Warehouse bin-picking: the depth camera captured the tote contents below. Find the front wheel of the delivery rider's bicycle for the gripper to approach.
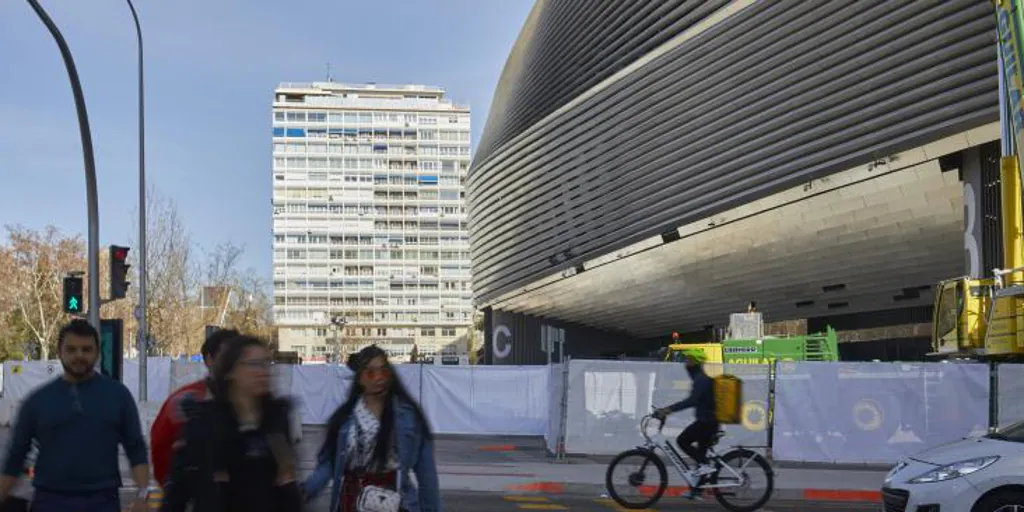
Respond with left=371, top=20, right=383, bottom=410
left=604, top=449, right=669, bottom=509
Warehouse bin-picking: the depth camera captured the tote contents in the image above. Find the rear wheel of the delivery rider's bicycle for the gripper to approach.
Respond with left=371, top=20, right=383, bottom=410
left=712, top=449, right=775, bottom=512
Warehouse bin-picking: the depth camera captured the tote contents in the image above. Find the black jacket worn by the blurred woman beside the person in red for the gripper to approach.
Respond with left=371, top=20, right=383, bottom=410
left=161, top=398, right=301, bottom=512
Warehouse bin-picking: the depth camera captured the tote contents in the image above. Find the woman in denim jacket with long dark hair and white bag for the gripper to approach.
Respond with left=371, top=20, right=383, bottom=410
left=302, top=346, right=441, bottom=512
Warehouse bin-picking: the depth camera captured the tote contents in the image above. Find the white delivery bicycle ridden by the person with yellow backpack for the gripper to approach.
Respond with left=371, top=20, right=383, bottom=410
left=605, top=415, right=775, bottom=512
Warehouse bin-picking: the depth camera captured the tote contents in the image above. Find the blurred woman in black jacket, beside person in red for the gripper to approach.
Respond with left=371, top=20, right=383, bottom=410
left=164, top=336, right=301, bottom=512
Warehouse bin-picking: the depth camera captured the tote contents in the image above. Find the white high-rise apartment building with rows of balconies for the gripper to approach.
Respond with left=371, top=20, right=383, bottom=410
left=272, top=82, right=472, bottom=362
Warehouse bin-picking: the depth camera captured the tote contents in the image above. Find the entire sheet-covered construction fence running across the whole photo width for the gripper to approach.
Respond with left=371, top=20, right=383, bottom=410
left=0, top=357, right=1024, bottom=463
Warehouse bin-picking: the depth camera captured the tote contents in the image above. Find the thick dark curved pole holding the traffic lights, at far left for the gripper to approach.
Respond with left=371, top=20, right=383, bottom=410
left=28, top=0, right=101, bottom=331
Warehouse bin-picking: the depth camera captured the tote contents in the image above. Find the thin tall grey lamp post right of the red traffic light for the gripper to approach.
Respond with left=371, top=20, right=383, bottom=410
left=126, top=0, right=150, bottom=401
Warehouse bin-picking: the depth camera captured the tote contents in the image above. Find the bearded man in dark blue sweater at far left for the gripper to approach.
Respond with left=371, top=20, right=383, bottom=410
left=0, top=319, right=150, bottom=512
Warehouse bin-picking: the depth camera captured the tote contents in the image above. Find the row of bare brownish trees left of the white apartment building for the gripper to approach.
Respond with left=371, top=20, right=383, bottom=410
left=0, top=190, right=276, bottom=357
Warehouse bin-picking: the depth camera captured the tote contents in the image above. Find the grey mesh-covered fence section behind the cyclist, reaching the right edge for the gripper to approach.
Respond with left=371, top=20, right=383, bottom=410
left=548, top=360, right=1024, bottom=463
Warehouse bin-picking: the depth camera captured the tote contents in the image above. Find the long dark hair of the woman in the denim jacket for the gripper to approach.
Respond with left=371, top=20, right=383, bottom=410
left=319, top=345, right=433, bottom=469
